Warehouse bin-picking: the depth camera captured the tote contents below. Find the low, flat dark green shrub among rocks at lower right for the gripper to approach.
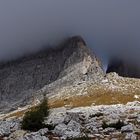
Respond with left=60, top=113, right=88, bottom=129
left=102, top=120, right=125, bottom=130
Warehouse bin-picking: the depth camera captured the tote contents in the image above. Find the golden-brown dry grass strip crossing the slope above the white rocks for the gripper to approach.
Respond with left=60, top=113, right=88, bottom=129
left=3, top=87, right=140, bottom=118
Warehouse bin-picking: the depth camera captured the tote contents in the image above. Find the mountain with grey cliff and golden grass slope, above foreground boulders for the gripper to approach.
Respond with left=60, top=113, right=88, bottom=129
left=0, top=36, right=140, bottom=112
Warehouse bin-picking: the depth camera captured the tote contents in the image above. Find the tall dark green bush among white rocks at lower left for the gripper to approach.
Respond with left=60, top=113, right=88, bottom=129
left=21, top=98, right=49, bottom=131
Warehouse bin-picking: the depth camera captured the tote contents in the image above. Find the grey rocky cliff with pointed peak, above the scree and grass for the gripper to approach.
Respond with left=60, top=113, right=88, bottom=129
left=0, top=36, right=103, bottom=111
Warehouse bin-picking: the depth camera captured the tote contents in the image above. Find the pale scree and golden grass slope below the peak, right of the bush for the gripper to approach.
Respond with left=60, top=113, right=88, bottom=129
left=46, top=73, right=140, bottom=107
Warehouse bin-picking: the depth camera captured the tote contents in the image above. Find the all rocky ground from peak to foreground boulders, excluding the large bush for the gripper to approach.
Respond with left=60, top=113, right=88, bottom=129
left=0, top=36, right=140, bottom=140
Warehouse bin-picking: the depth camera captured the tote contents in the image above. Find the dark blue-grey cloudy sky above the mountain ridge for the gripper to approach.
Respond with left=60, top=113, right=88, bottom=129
left=0, top=0, right=140, bottom=68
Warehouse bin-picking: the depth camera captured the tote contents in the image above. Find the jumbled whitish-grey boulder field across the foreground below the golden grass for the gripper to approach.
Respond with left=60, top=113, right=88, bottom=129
left=0, top=102, right=140, bottom=140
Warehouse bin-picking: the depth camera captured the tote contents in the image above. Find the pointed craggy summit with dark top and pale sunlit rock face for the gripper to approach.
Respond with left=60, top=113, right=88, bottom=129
left=59, top=36, right=103, bottom=81
